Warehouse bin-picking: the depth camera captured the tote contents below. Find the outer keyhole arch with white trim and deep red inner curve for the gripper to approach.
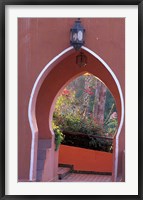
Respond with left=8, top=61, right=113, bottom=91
left=28, top=47, right=124, bottom=181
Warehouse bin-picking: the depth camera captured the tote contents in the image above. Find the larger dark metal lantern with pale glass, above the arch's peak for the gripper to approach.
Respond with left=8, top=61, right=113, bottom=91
left=70, top=18, right=85, bottom=51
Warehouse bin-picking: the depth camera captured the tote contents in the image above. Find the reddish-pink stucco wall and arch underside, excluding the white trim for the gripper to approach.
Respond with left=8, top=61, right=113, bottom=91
left=18, top=18, right=125, bottom=179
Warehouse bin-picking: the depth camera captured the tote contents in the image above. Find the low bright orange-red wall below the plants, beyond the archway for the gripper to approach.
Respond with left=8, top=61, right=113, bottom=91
left=59, top=145, right=113, bottom=172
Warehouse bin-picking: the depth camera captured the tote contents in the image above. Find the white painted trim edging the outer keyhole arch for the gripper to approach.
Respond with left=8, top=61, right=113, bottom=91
left=28, top=46, right=124, bottom=181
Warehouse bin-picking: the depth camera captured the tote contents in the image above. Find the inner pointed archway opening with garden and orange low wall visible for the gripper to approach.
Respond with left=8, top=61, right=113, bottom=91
left=52, top=72, right=118, bottom=181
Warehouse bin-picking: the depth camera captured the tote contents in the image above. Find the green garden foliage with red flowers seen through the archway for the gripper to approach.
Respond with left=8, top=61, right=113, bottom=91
left=53, top=76, right=118, bottom=152
